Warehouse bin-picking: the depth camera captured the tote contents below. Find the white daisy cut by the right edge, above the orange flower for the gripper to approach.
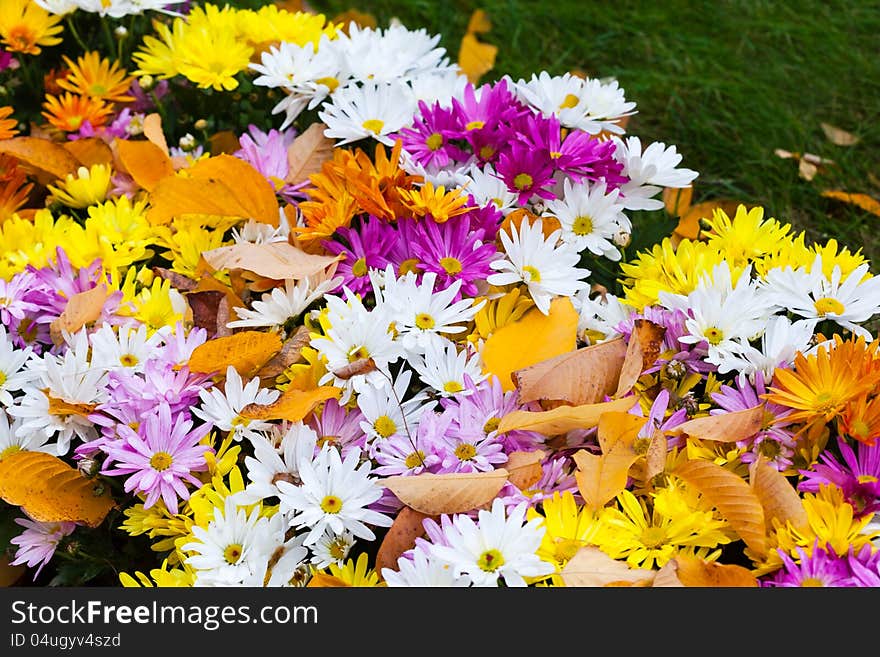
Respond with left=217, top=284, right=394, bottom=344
left=761, top=253, right=880, bottom=340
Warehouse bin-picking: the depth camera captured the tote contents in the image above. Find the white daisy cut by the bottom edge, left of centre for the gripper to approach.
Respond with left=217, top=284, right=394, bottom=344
left=181, top=496, right=283, bottom=586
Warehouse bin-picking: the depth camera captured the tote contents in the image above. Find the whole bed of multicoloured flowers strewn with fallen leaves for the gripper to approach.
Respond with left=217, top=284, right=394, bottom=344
left=0, top=0, right=880, bottom=587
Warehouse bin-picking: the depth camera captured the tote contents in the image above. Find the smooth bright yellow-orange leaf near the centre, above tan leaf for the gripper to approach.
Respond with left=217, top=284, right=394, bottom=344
left=481, top=297, right=578, bottom=394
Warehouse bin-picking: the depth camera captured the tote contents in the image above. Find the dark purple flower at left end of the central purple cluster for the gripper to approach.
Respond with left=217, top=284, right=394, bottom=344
left=323, top=215, right=397, bottom=294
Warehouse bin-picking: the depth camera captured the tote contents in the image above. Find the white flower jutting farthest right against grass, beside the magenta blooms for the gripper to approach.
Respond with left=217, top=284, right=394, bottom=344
left=612, top=136, right=699, bottom=210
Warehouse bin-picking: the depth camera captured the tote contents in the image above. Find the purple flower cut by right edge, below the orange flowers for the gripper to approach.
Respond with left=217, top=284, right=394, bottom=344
left=798, top=436, right=880, bottom=517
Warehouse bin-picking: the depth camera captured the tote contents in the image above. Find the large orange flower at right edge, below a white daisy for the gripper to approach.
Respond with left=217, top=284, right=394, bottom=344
left=764, top=335, right=880, bottom=427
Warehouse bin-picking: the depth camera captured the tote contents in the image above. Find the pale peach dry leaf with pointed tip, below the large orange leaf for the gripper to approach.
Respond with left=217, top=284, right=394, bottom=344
left=202, top=242, right=344, bottom=280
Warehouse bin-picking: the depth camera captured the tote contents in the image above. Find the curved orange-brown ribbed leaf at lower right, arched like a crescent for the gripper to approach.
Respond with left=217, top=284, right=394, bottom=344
left=673, top=460, right=767, bottom=555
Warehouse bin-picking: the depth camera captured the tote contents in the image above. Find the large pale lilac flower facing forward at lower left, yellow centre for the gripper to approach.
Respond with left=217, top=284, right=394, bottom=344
left=101, top=404, right=211, bottom=514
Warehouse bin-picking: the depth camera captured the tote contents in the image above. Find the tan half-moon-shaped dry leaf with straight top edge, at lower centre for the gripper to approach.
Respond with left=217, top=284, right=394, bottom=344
left=380, top=468, right=508, bottom=516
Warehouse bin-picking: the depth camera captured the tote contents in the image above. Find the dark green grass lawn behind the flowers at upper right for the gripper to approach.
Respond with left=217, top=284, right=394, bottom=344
left=310, top=0, right=880, bottom=263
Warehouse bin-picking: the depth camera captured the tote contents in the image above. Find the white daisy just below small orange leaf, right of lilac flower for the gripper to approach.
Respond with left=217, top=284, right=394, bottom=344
left=192, top=365, right=281, bottom=441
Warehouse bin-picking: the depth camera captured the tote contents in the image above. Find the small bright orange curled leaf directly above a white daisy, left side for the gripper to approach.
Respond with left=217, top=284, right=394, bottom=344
left=188, top=331, right=281, bottom=377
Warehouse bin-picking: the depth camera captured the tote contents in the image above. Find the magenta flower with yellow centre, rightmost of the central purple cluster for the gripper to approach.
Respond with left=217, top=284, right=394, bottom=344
left=411, top=214, right=497, bottom=301
